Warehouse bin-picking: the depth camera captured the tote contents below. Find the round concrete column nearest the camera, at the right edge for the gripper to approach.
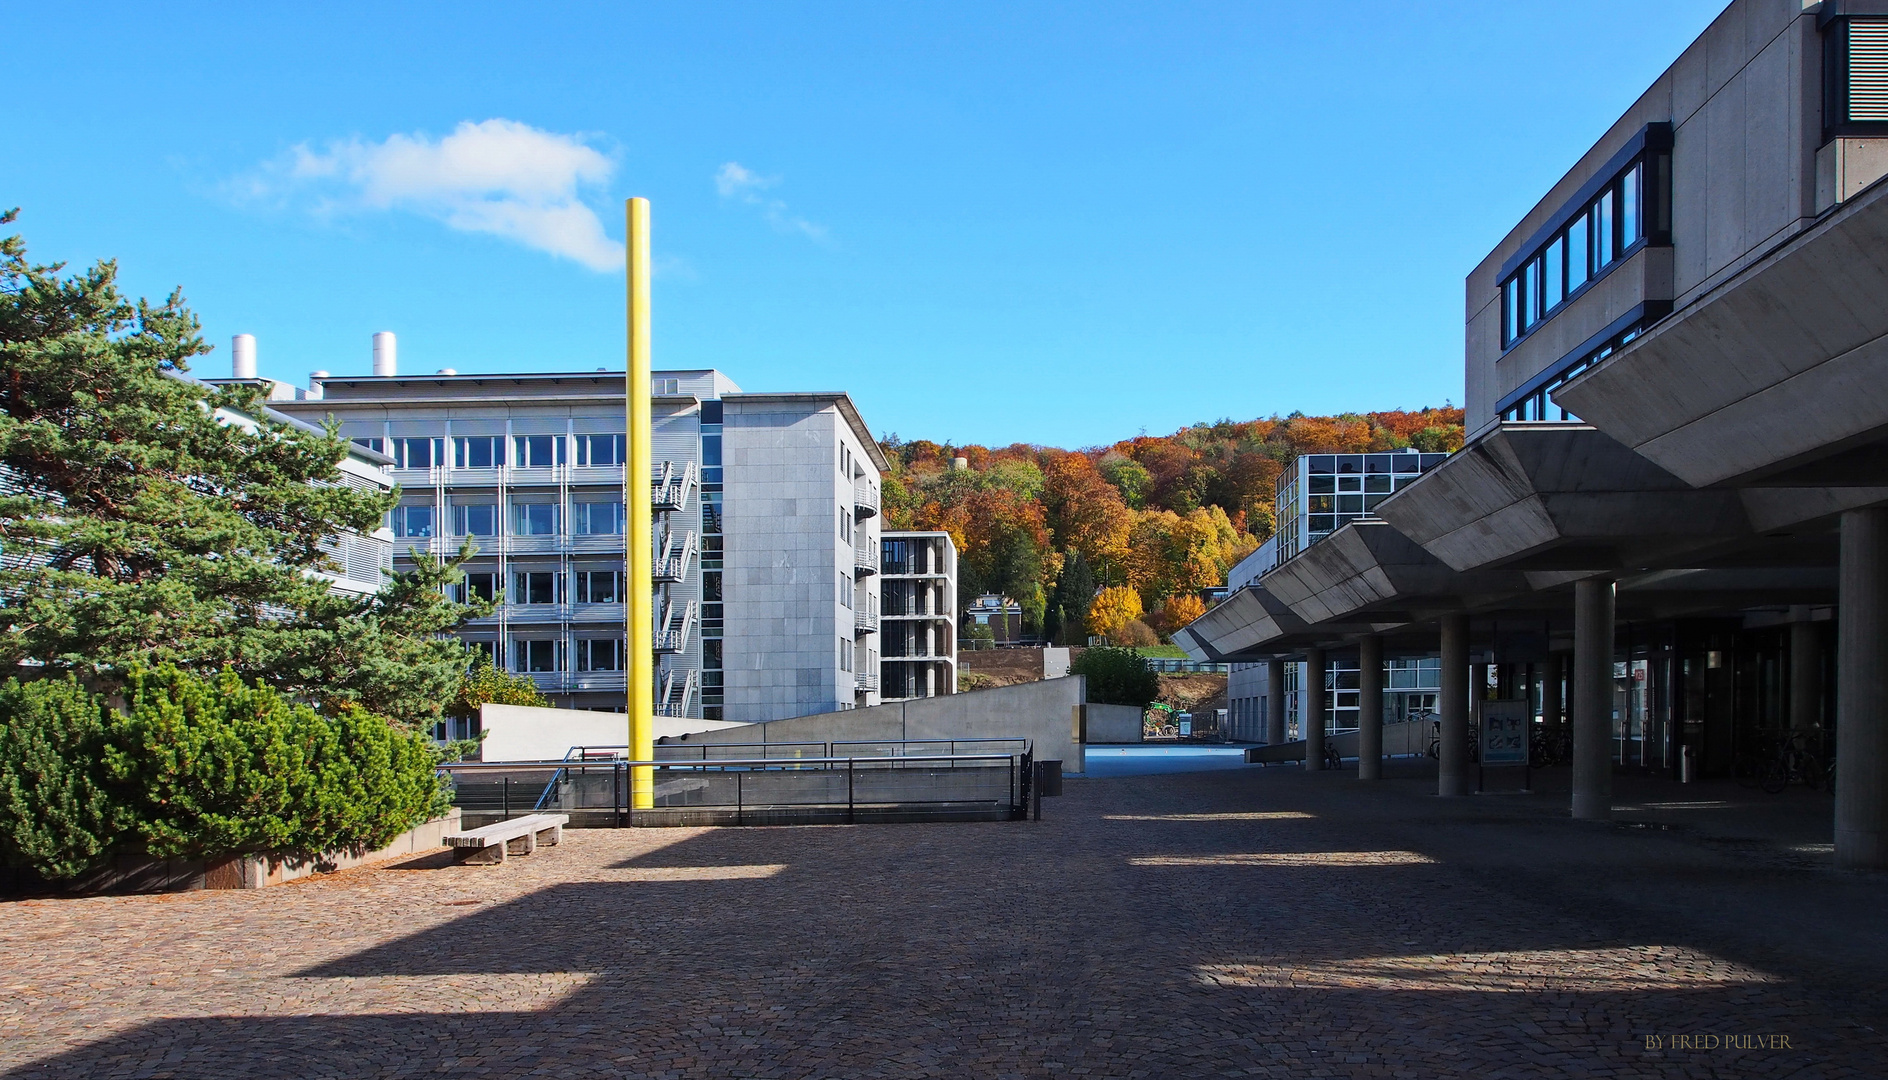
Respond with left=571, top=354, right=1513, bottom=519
left=1835, top=506, right=1888, bottom=869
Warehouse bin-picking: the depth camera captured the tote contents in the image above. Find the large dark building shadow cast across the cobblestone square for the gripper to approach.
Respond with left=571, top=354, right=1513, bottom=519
left=4, top=774, right=1888, bottom=1080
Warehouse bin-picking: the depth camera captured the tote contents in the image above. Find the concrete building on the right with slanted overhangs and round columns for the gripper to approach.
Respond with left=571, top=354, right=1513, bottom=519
left=1182, top=0, right=1888, bottom=867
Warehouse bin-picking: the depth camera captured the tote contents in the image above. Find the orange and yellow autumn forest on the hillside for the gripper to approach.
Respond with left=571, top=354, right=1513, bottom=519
left=880, top=406, right=1463, bottom=646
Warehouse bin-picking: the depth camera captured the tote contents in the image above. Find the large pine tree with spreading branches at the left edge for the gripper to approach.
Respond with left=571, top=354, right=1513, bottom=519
left=0, top=211, right=474, bottom=727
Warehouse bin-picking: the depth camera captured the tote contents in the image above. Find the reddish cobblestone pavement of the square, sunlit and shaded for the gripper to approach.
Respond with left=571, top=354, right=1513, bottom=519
left=0, top=768, right=1888, bottom=1080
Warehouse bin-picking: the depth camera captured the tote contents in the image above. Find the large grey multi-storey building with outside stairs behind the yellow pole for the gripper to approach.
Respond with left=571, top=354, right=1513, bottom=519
left=274, top=334, right=884, bottom=721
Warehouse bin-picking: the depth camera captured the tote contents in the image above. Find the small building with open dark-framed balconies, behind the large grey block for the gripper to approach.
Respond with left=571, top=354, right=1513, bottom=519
left=878, top=532, right=957, bottom=700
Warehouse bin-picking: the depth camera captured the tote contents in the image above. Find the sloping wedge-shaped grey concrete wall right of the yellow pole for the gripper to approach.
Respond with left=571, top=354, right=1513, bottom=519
left=660, top=676, right=1095, bottom=772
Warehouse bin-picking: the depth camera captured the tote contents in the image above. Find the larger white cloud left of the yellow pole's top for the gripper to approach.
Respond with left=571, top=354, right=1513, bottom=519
left=251, top=119, right=623, bottom=270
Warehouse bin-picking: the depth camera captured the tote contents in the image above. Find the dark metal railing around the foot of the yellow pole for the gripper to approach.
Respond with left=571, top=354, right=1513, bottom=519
left=440, top=744, right=1031, bottom=825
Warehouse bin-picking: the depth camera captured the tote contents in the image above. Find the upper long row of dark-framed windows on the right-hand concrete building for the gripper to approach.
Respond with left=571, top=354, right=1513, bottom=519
left=1501, top=157, right=1658, bottom=349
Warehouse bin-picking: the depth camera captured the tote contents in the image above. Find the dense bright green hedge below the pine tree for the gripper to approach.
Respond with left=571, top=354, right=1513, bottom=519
left=0, top=667, right=446, bottom=880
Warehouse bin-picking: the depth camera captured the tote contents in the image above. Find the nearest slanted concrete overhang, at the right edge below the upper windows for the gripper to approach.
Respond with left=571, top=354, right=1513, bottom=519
left=1554, top=171, right=1888, bottom=487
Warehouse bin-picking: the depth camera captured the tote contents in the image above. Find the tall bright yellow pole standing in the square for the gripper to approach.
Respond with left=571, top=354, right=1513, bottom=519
left=623, top=198, right=655, bottom=810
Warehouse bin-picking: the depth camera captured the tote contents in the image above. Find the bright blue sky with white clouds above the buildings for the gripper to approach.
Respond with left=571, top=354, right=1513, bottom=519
left=0, top=0, right=1722, bottom=446
